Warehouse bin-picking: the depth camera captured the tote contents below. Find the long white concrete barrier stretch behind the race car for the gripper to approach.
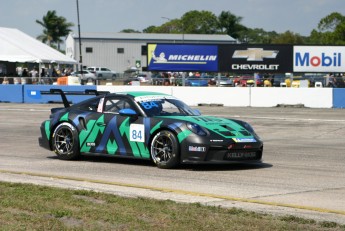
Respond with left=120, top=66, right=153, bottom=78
left=97, top=86, right=334, bottom=108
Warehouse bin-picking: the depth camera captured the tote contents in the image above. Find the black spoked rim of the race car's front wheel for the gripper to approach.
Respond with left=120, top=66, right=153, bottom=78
left=151, top=135, right=173, bottom=163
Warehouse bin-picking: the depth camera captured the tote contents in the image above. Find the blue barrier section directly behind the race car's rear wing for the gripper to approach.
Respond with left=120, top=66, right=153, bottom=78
left=23, top=85, right=97, bottom=103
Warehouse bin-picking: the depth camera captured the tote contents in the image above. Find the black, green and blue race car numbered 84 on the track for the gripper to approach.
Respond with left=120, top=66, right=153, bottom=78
left=38, top=89, right=263, bottom=168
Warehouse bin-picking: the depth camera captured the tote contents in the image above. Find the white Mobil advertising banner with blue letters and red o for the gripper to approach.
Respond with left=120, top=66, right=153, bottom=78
left=293, top=46, right=345, bottom=73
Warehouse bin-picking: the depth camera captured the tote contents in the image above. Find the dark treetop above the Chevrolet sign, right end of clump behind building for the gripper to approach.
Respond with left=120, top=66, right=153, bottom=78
left=218, top=11, right=248, bottom=39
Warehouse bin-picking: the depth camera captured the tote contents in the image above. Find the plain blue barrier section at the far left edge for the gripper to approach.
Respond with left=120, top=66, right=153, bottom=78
left=0, top=84, right=23, bottom=103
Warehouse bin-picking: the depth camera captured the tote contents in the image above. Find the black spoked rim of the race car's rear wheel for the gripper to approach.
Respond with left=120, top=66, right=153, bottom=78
left=54, top=128, right=74, bottom=154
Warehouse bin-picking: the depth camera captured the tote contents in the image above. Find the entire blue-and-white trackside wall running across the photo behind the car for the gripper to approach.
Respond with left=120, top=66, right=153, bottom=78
left=0, top=85, right=345, bottom=108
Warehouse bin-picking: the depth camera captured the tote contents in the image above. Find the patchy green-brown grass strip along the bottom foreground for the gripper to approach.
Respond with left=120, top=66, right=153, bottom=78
left=0, top=182, right=345, bottom=231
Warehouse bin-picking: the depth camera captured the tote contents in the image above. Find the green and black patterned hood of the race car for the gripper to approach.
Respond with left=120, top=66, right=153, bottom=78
left=160, top=116, right=254, bottom=138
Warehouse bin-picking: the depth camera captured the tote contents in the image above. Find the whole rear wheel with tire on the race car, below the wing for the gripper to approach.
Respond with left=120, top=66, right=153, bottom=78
left=52, top=122, right=80, bottom=160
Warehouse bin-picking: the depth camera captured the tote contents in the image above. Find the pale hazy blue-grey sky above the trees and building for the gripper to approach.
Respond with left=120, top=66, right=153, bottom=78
left=0, top=0, right=345, bottom=37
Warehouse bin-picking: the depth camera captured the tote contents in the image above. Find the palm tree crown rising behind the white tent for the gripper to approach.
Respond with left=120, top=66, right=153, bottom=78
left=36, top=10, right=74, bottom=50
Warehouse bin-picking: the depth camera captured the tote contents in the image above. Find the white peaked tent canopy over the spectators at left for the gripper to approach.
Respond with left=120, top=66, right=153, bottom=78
left=0, top=27, right=77, bottom=64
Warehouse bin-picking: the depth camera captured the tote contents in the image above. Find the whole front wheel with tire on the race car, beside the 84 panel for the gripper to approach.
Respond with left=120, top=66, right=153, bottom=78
left=150, top=130, right=180, bottom=169
